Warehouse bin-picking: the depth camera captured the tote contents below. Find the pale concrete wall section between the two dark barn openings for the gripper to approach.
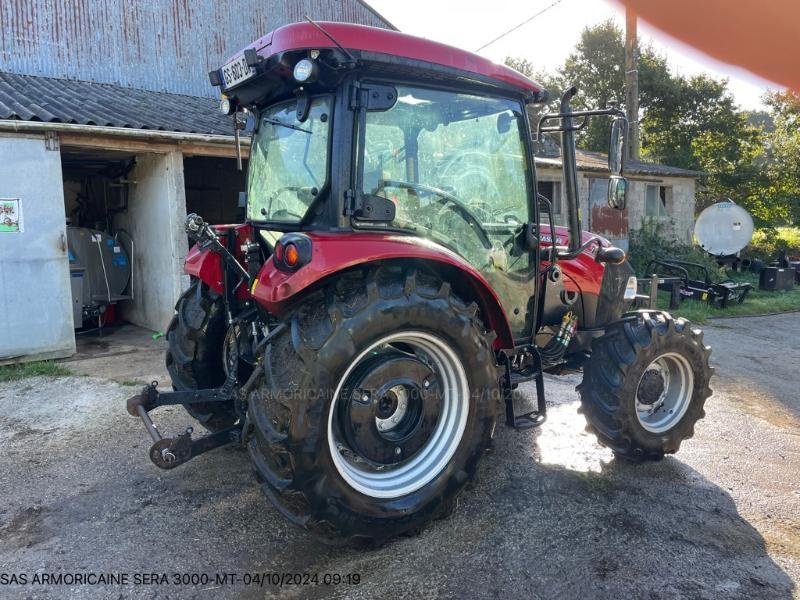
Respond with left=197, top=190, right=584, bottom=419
left=115, top=151, right=188, bottom=331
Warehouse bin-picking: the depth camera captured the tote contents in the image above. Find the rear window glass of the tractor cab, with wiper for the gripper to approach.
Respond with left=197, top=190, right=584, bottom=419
left=247, top=96, right=331, bottom=223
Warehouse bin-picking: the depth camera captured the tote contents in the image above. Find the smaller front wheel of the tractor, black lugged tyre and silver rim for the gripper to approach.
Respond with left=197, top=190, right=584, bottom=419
left=578, top=311, right=714, bottom=462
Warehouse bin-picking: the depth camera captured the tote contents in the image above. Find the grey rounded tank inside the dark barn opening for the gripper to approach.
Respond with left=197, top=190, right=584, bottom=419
left=67, top=227, right=131, bottom=329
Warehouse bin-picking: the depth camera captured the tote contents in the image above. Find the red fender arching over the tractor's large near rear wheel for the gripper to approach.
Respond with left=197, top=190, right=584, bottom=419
left=250, top=232, right=514, bottom=349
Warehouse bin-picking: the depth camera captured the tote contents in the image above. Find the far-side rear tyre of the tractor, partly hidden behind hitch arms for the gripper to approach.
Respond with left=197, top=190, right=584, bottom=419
left=166, top=279, right=237, bottom=432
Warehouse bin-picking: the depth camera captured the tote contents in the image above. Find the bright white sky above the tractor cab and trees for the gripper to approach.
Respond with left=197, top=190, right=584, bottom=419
left=368, top=0, right=780, bottom=110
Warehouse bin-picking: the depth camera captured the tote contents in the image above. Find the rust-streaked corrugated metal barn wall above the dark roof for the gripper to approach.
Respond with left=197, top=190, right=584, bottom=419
left=0, top=0, right=387, bottom=97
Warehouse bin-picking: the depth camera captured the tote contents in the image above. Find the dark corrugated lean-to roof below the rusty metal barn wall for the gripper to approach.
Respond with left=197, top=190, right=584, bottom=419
left=0, top=72, right=233, bottom=135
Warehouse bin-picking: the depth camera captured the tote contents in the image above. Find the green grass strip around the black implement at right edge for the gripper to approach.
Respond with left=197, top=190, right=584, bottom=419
left=658, top=273, right=800, bottom=323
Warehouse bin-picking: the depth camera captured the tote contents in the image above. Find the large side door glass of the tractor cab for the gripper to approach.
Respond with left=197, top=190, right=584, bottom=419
left=361, top=86, right=529, bottom=266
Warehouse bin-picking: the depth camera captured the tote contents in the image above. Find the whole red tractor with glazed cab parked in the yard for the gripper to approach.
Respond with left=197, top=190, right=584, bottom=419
left=128, top=21, right=712, bottom=543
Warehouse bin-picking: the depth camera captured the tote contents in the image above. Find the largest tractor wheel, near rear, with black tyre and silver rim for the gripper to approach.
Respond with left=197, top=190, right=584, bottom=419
left=248, top=266, right=500, bottom=546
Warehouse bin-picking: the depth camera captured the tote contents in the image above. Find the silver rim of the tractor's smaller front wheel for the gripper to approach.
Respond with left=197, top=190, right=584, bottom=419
left=636, top=352, right=694, bottom=433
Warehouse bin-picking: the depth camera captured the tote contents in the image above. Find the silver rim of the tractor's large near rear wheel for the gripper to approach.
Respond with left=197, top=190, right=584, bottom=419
left=327, top=331, right=470, bottom=498
